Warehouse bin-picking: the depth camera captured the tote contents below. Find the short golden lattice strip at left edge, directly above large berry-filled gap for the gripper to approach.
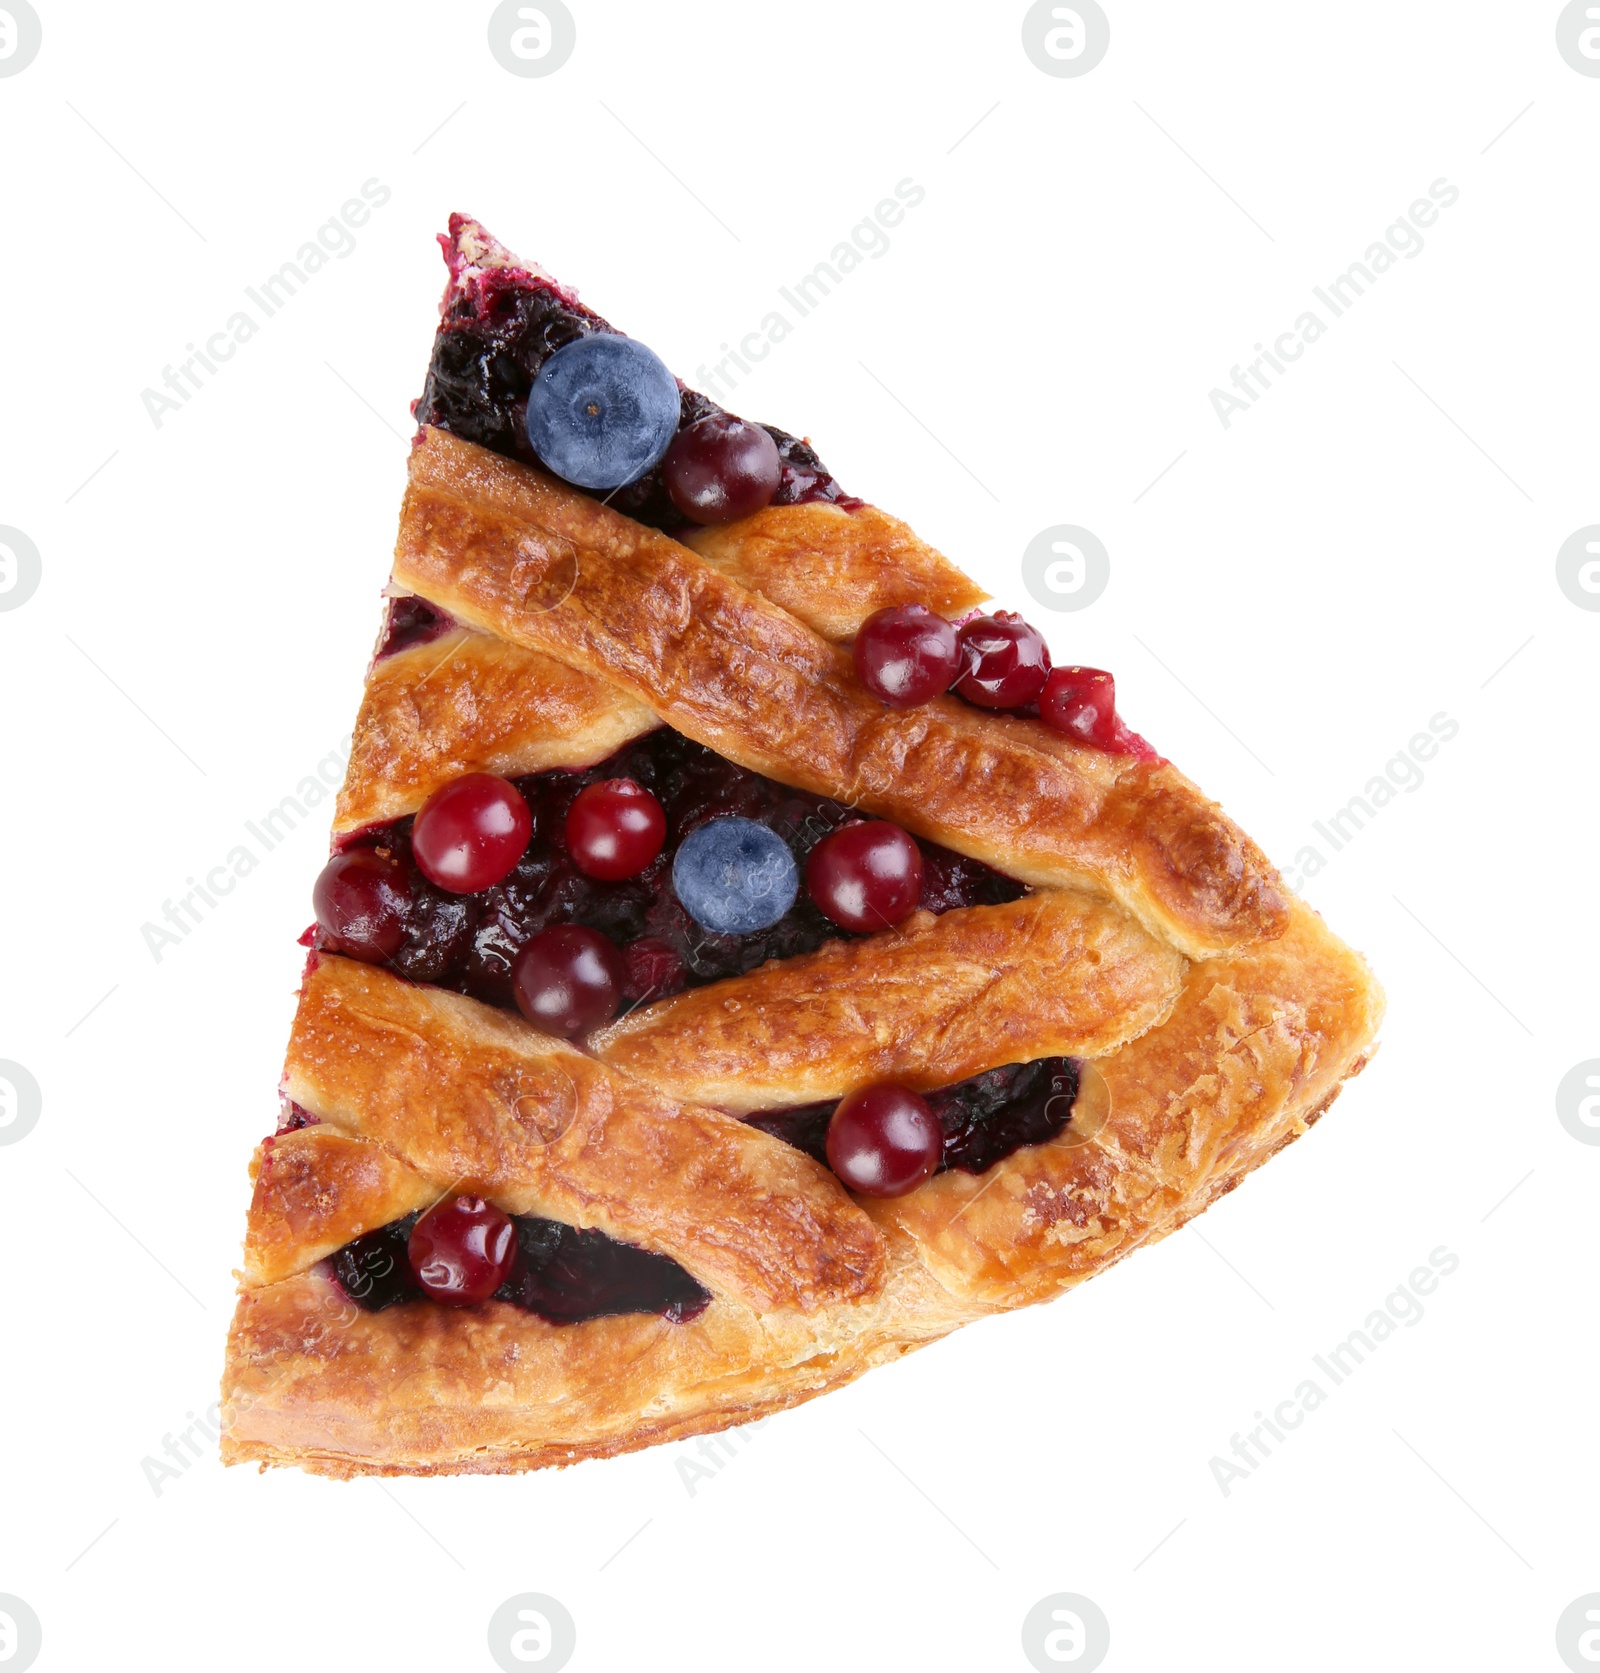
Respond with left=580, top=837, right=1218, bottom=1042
left=333, top=629, right=659, bottom=831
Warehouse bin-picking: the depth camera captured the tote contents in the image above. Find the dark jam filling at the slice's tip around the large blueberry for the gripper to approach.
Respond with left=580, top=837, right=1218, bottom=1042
left=415, top=244, right=862, bottom=532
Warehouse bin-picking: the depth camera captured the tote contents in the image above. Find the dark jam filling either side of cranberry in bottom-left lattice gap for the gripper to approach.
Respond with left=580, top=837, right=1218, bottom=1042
left=328, top=1215, right=711, bottom=1325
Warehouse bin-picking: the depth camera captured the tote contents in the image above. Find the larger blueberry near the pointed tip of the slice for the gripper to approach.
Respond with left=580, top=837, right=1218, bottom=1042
left=527, top=333, right=679, bottom=489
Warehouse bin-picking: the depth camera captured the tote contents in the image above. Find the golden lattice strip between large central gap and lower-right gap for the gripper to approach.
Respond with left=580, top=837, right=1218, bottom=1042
left=589, top=890, right=1185, bottom=1113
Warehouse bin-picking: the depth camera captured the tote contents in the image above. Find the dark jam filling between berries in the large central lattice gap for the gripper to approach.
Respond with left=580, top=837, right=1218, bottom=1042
left=329, top=726, right=1028, bottom=1012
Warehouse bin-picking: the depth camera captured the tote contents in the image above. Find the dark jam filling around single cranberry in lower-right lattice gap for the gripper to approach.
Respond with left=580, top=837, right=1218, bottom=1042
left=745, top=1057, right=1078, bottom=1173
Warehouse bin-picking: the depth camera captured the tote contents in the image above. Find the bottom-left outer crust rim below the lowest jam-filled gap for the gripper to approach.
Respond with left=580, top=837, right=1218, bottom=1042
left=223, top=1250, right=964, bottom=1477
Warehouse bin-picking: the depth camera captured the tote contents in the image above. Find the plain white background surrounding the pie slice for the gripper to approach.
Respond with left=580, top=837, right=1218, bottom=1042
left=0, top=0, right=1600, bottom=1673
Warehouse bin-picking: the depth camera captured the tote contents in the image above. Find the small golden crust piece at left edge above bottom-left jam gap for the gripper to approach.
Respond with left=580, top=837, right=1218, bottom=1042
left=241, top=1128, right=438, bottom=1285
